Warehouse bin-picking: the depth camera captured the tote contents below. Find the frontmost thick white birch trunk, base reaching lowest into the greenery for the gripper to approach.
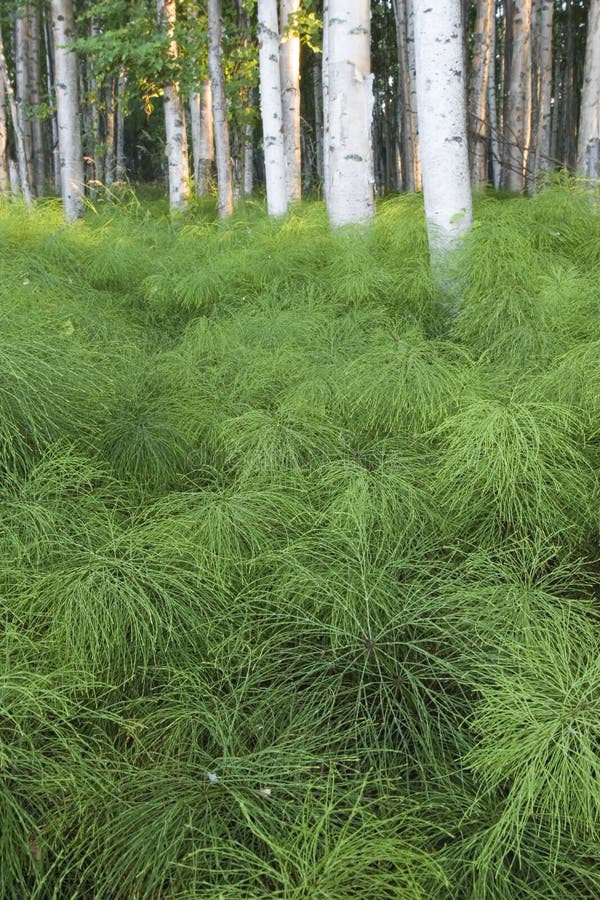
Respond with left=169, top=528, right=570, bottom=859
left=415, top=0, right=472, bottom=266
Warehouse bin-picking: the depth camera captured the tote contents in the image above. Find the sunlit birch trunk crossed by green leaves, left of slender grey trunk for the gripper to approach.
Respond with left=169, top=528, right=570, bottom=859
left=157, top=0, right=190, bottom=211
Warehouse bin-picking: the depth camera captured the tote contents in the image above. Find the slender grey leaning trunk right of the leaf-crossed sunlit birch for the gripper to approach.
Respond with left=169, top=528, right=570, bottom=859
left=208, top=0, right=233, bottom=217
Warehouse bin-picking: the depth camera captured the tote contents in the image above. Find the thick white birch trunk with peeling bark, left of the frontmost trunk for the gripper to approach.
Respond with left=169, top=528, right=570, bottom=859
left=325, top=0, right=375, bottom=227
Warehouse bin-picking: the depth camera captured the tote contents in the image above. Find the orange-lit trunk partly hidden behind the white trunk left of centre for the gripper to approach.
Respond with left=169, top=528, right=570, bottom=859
left=279, top=0, right=302, bottom=203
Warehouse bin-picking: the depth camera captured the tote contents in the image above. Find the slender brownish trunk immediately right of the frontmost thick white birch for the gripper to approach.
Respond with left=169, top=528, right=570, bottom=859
left=469, top=0, right=496, bottom=187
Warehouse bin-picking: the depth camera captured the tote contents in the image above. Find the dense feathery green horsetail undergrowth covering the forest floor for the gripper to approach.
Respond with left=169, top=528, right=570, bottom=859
left=0, top=185, right=600, bottom=900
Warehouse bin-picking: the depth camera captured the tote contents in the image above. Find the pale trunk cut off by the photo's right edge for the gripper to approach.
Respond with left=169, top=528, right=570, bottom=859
left=577, top=0, right=600, bottom=178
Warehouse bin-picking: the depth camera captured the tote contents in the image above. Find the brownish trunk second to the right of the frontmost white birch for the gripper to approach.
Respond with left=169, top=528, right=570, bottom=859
left=504, top=0, right=531, bottom=191
